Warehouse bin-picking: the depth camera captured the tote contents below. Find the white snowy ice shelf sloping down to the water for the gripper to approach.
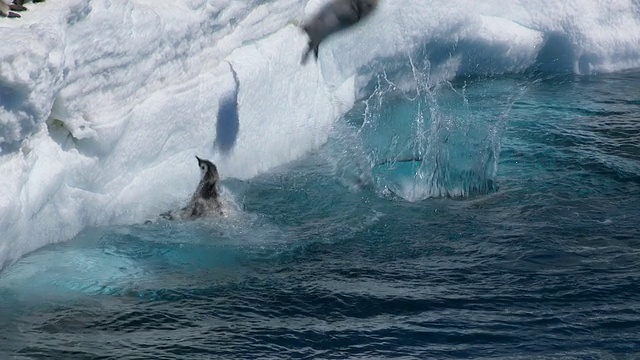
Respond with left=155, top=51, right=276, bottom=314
left=0, top=0, right=640, bottom=269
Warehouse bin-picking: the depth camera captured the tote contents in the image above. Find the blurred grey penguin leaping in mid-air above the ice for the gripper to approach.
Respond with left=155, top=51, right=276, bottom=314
left=301, top=0, right=378, bottom=64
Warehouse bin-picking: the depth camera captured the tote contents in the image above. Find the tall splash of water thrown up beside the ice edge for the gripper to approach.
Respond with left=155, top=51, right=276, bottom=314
left=340, top=55, right=527, bottom=201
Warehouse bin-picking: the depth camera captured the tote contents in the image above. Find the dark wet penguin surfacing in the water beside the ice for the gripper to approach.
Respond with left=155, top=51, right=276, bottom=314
left=160, top=156, right=223, bottom=220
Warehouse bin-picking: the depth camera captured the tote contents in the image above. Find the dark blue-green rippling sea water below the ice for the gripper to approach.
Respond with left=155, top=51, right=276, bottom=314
left=0, top=72, right=640, bottom=359
